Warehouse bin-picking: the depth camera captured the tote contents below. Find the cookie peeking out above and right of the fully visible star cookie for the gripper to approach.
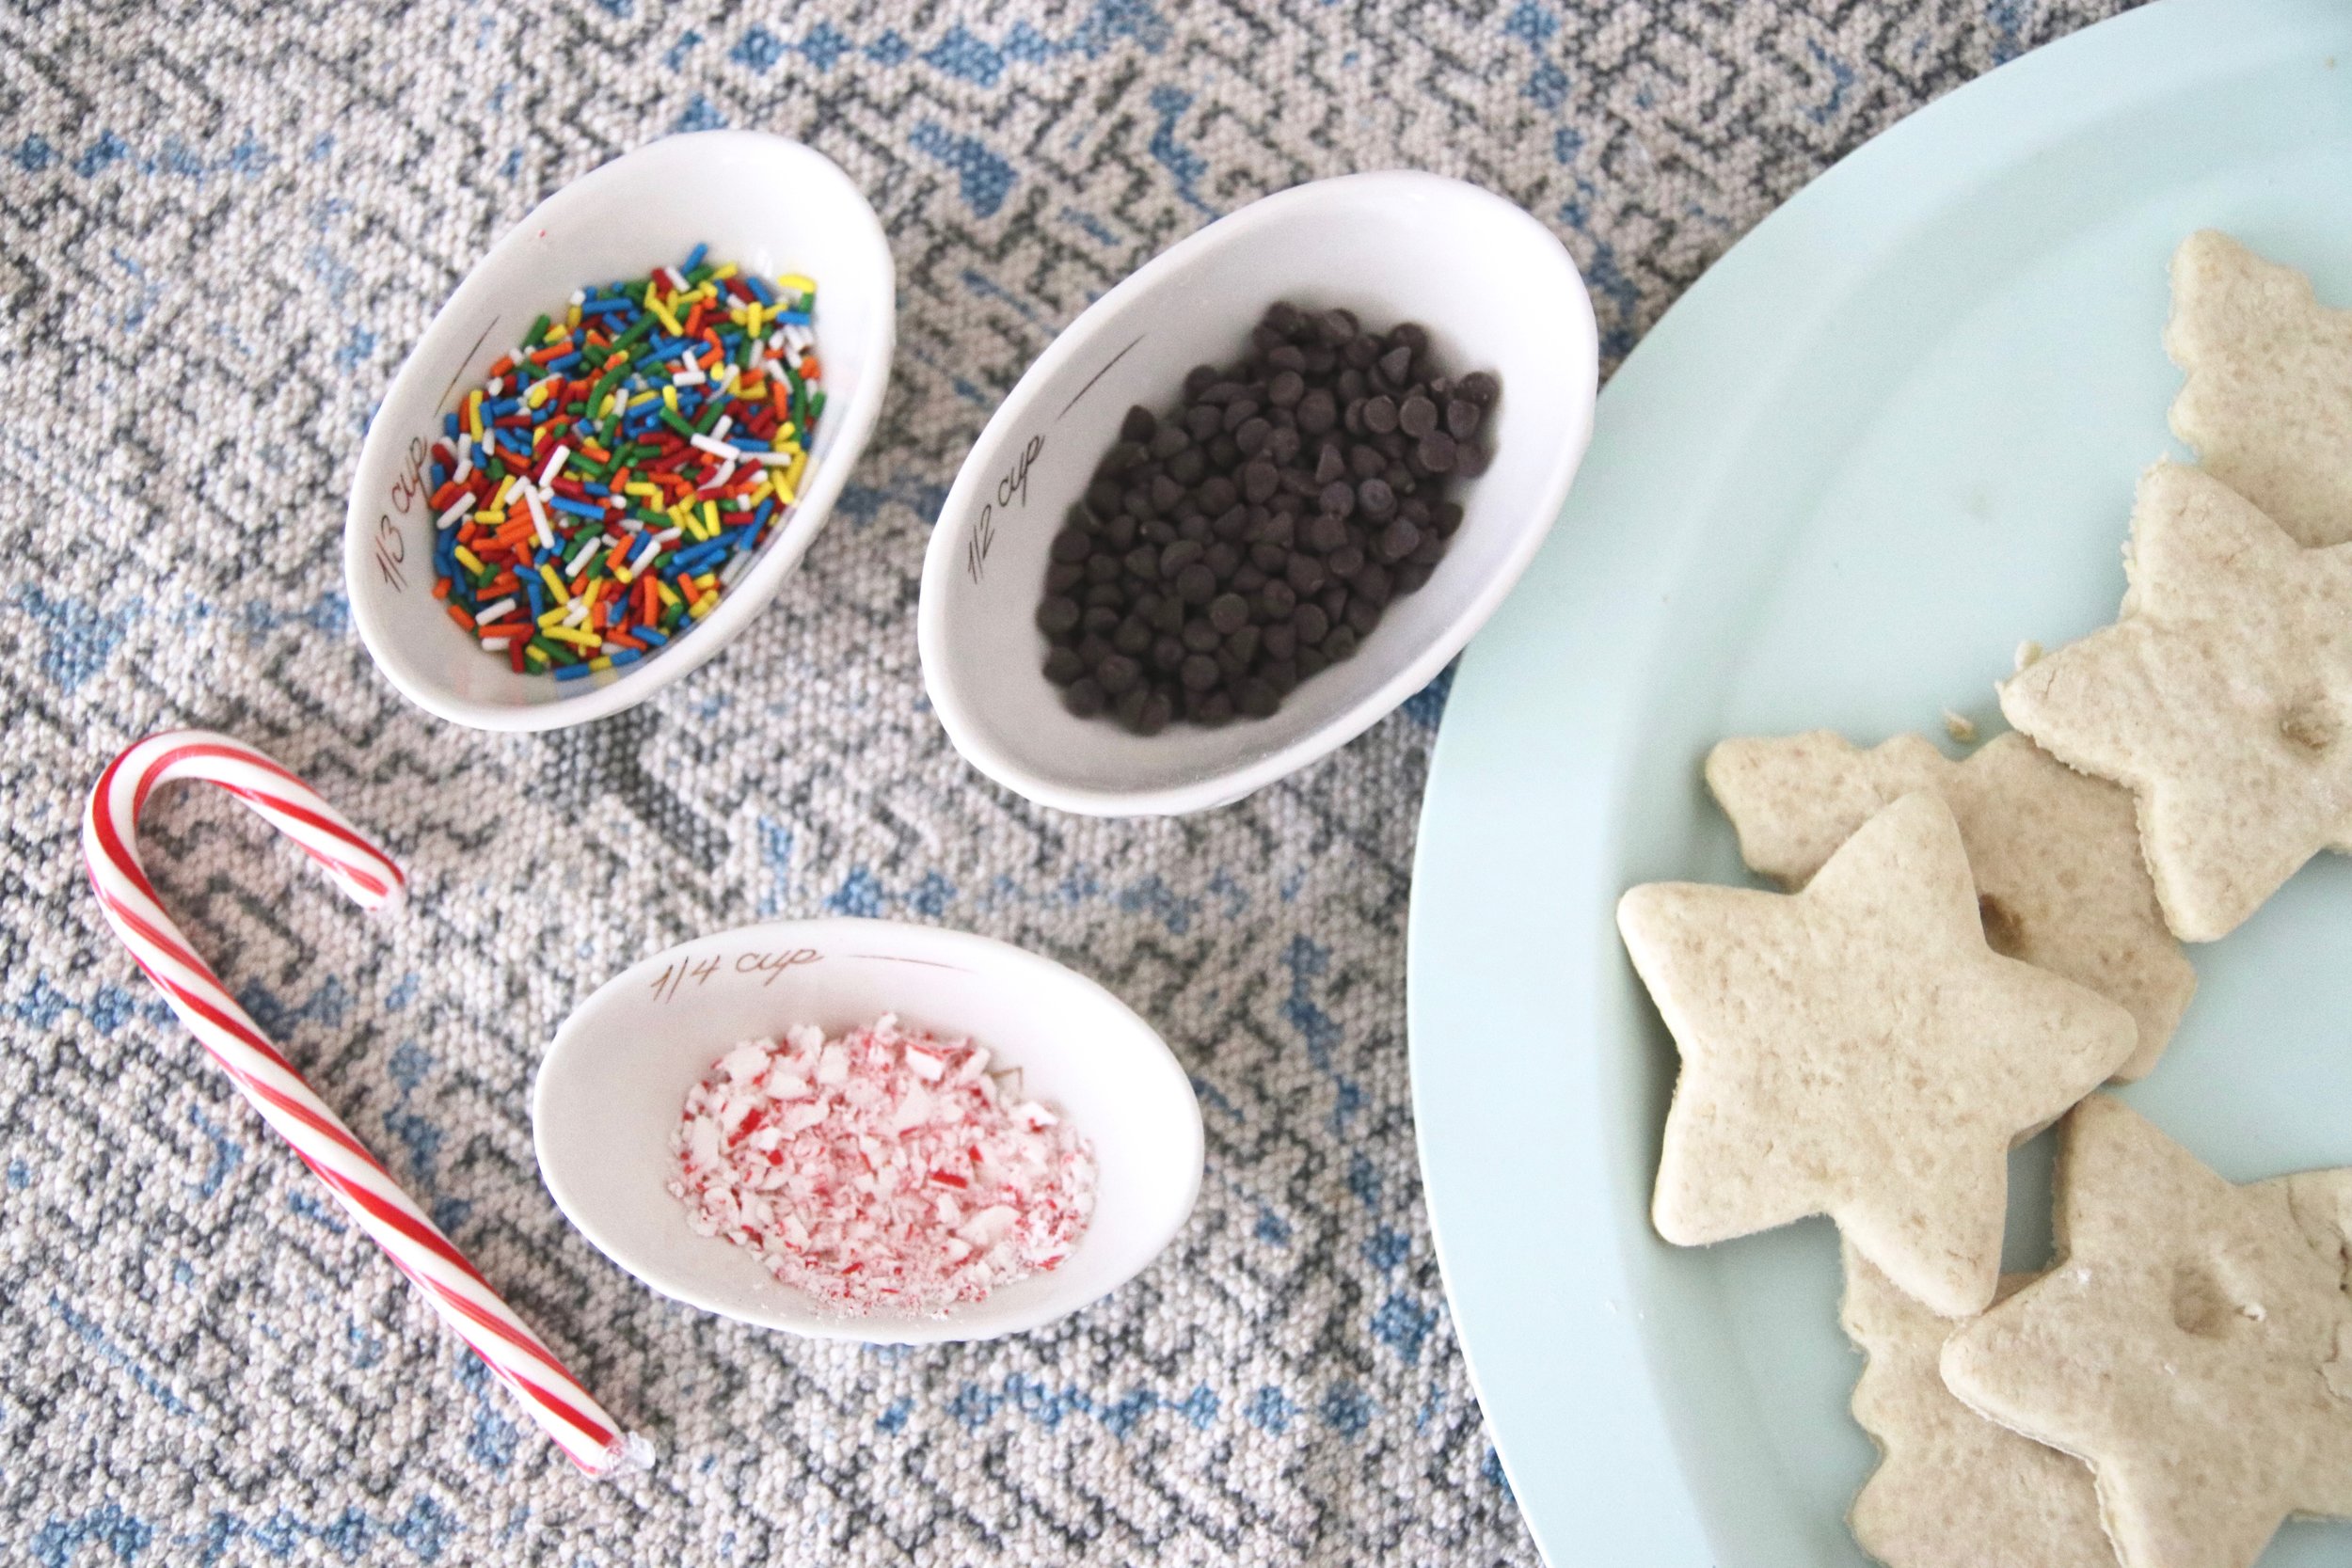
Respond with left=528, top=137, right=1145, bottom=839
left=1708, top=729, right=2197, bottom=1082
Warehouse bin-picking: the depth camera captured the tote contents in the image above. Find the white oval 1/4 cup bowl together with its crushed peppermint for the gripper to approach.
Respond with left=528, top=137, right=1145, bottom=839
left=532, top=919, right=1202, bottom=1345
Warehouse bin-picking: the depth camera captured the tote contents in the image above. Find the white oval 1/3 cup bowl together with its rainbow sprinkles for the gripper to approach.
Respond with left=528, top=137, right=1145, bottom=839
left=343, top=132, right=897, bottom=729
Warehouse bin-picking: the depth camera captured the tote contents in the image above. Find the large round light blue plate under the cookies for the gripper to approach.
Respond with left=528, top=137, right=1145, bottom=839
left=1411, top=0, right=2352, bottom=1568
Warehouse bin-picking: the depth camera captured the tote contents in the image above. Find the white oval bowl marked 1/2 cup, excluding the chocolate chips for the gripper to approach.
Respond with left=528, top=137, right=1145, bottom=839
left=917, top=171, right=1599, bottom=816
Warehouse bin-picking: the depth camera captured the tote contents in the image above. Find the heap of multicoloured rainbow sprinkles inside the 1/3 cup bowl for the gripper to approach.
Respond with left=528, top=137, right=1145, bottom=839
left=431, top=245, right=826, bottom=679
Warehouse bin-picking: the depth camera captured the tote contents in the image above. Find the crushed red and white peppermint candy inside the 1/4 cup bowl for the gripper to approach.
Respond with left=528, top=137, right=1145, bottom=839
left=671, top=1013, right=1094, bottom=1317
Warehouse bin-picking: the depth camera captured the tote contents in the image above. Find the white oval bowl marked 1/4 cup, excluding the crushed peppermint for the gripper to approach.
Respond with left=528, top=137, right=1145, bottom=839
left=532, top=919, right=1202, bottom=1345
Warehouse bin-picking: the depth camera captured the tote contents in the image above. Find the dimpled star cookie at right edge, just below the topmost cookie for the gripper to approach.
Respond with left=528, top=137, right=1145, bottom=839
left=2002, top=463, right=2352, bottom=942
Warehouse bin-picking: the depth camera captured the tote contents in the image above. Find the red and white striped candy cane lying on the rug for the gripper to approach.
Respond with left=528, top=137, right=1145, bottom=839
left=83, top=729, right=649, bottom=1477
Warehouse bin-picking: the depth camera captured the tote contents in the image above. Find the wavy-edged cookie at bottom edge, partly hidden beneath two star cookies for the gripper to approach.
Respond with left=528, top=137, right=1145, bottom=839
left=1839, top=1246, right=2115, bottom=1568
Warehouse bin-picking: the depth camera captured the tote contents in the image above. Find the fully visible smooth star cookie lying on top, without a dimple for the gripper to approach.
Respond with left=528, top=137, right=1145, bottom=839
left=1618, top=790, right=2134, bottom=1317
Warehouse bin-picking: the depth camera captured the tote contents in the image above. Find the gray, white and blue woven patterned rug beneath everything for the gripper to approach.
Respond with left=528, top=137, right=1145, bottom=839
left=0, top=0, right=2112, bottom=1568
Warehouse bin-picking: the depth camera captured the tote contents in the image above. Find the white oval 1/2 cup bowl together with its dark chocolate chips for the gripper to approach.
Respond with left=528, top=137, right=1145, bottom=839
left=917, top=171, right=1599, bottom=816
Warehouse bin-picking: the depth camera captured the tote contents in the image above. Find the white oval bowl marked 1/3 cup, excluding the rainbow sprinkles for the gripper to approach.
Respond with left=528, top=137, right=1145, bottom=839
left=343, top=132, right=897, bottom=729
